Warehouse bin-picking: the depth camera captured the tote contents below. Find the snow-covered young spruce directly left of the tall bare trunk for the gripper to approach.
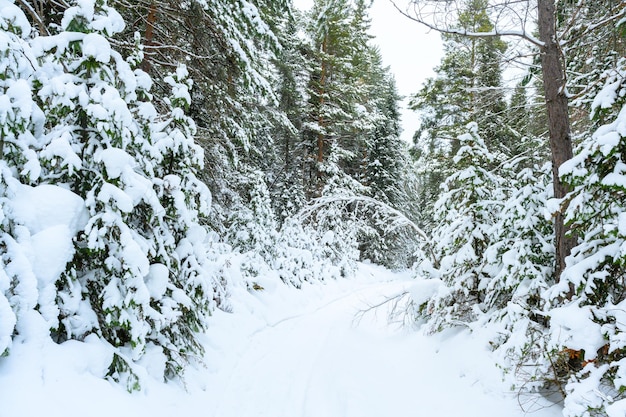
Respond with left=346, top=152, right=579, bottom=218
left=477, top=157, right=554, bottom=390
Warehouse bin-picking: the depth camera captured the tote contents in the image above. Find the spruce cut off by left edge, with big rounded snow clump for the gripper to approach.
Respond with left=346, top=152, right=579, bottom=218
left=0, top=1, right=91, bottom=362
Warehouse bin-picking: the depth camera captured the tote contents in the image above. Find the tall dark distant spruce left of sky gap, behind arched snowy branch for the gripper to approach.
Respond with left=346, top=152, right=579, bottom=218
left=357, top=53, right=417, bottom=268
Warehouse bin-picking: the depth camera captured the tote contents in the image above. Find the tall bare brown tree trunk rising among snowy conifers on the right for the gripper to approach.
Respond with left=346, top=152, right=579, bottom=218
left=538, top=0, right=576, bottom=281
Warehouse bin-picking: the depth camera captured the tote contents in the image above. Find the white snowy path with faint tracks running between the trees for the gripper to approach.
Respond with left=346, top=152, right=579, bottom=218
left=205, top=264, right=554, bottom=417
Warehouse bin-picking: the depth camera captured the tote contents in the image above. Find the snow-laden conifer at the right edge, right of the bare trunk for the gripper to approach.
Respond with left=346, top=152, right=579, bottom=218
left=546, top=61, right=626, bottom=417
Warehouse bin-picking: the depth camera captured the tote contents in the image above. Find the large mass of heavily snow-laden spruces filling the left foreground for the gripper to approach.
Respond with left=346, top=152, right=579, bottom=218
left=0, top=0, right=224, bottom=389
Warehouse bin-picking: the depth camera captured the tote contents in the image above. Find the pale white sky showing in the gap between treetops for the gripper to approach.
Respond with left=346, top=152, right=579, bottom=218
left=294, top=0, right=443, bottom=142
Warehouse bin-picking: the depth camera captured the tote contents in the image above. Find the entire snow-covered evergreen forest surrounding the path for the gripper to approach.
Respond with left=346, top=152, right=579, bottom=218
left=0, top=0, right=626, bottom=416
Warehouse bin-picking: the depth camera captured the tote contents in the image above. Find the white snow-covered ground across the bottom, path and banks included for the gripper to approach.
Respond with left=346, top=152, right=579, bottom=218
left=0, top=265, right=561, bottom=417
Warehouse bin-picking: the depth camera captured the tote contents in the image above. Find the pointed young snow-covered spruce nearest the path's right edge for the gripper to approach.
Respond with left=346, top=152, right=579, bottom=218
left=418, top=123, right=505, bottom=330
